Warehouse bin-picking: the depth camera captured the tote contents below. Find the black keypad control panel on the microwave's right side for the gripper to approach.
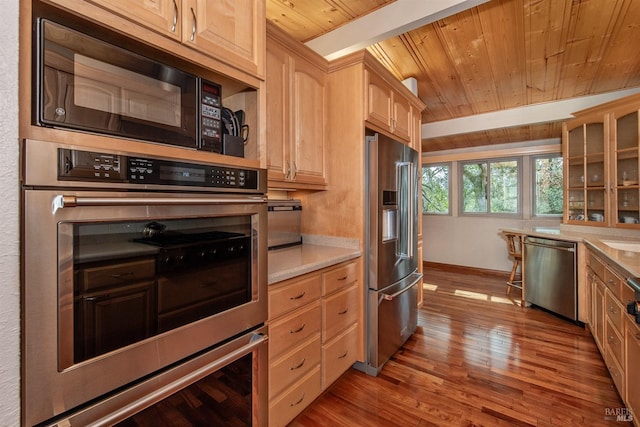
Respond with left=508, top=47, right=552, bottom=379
left=198, top=80, right=222, bottom=153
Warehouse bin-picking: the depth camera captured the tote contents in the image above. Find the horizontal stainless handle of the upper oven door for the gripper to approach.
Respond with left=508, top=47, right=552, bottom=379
left=51, top=194, right=266, bottom=213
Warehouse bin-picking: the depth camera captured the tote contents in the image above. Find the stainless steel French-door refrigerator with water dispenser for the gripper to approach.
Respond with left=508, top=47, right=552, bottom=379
left=355, top=134, right=422, bottom=376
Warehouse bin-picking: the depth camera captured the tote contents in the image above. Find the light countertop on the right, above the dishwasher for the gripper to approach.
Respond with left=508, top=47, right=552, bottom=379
left=501, top=227, right=640, bottom=277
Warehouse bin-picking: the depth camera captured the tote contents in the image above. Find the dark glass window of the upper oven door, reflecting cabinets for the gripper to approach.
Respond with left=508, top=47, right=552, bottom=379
left=70, top=215, right=253, bottom=363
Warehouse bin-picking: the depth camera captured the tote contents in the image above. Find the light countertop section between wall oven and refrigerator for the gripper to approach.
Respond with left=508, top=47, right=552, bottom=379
left=268, top=237, right=362, bottom=285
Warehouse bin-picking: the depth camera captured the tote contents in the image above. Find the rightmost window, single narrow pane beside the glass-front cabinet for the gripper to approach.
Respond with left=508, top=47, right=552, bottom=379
left=532, top=155, right=563, bottom=216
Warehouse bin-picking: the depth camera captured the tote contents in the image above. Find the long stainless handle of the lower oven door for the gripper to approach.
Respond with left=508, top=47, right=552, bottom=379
left=90, top=333, right=269, bottom=427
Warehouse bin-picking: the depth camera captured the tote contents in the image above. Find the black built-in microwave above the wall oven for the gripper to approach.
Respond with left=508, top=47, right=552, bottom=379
left=33, top=18, right=224, bottom=153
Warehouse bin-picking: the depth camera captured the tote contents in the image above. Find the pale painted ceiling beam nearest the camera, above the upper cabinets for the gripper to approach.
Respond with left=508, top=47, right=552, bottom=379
left=306, top=0, right=488, bottom=61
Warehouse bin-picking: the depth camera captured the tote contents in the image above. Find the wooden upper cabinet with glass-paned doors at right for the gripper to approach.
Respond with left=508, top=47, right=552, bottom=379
left=562, top=95, right=640, bottom=228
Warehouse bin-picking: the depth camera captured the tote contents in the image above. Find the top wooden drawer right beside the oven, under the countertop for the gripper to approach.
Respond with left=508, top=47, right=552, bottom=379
left=268, top=274, right=320, bottom=319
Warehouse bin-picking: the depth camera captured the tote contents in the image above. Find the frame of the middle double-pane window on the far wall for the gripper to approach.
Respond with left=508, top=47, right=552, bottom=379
left=457, top=156, right=524, bottom=218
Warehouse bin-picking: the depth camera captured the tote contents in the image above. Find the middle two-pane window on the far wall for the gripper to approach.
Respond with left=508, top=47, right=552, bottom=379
left=460, top=159, right=520, bottom=214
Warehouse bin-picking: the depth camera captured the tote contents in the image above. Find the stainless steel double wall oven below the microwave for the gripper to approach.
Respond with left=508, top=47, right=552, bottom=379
left=22, top=140, right=267, bottom=425
